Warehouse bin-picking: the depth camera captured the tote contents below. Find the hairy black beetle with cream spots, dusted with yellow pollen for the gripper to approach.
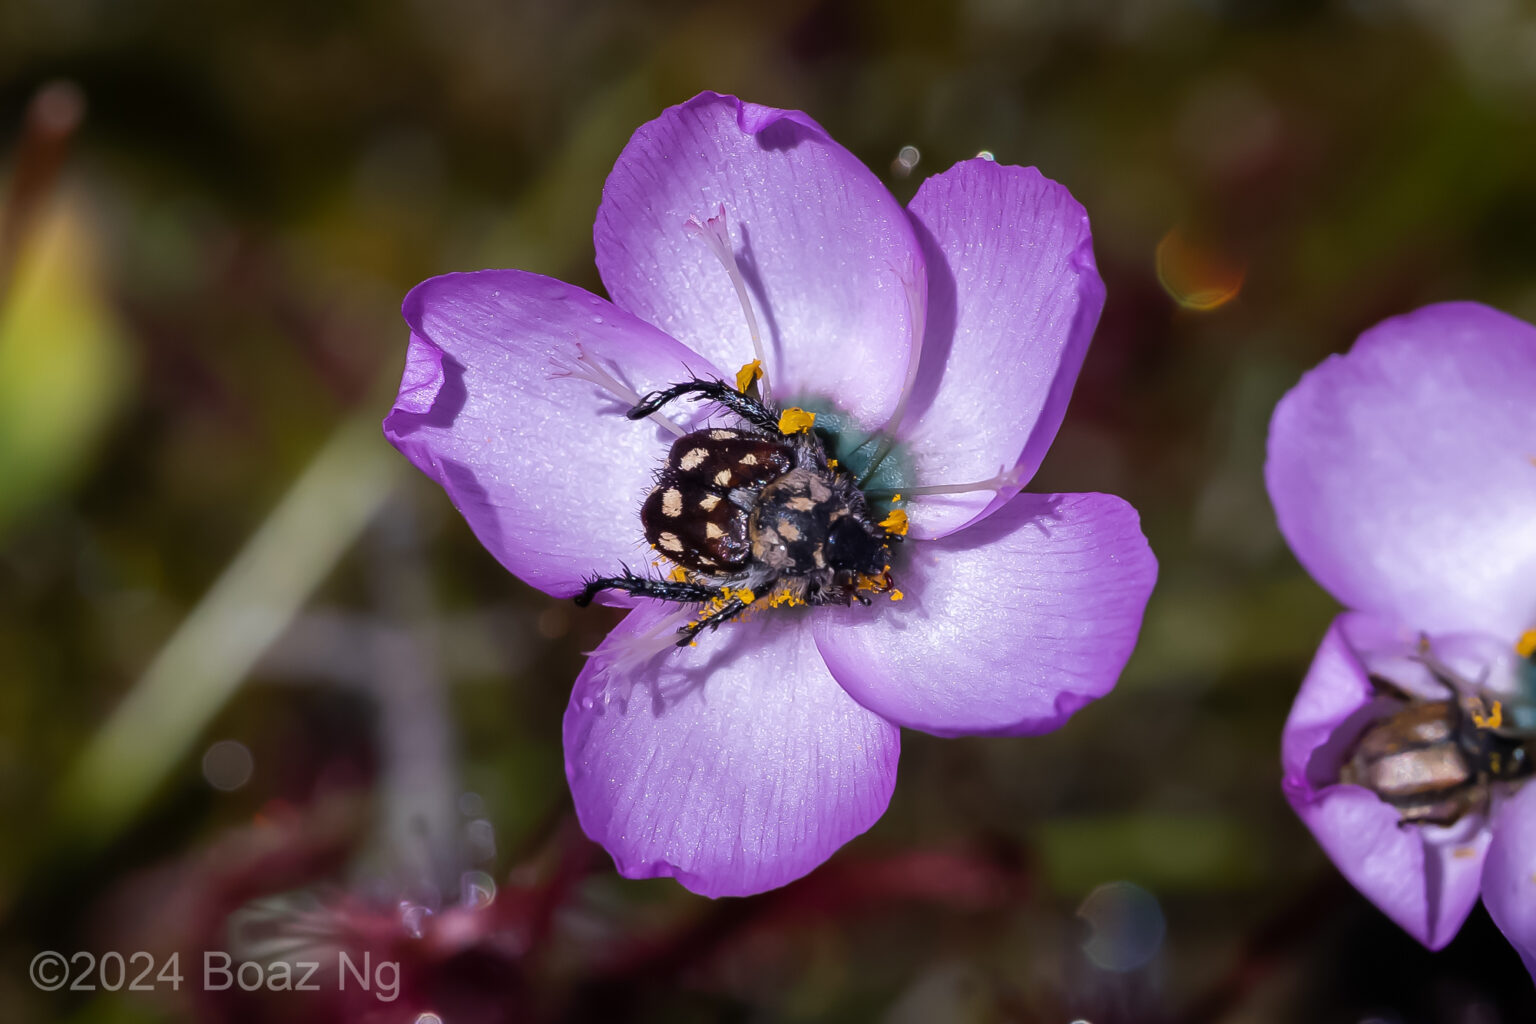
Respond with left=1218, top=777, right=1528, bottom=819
left=576, top=379, right=902, bottom=646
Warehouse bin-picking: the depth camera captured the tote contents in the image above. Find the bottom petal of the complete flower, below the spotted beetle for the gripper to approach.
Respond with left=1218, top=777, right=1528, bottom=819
left=565, top=603, right=900, bottom=897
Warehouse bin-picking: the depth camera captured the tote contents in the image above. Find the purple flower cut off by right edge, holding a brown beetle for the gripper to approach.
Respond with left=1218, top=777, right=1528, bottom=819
left=1266, top=302, right=1536, bottom=972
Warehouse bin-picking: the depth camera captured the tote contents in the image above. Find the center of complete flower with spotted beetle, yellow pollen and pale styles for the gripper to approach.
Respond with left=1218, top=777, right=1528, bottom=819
left=554, top=206, right=1017, bottom=648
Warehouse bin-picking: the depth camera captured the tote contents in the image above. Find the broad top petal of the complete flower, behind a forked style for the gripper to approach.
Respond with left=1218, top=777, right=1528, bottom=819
left=593, top=92, right=925, bottom=428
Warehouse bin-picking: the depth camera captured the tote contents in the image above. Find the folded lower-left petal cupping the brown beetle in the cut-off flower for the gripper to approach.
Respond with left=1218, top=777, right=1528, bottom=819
left=1281, top=614, right=1488, bottom=949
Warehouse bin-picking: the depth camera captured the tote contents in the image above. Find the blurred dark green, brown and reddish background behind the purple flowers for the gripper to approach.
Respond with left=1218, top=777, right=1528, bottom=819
left=0, top=0, right=1536, bottom=1024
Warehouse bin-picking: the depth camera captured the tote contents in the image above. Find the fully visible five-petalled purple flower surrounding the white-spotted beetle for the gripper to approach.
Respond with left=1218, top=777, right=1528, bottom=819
left=384, top=94, right=1157, bottom=897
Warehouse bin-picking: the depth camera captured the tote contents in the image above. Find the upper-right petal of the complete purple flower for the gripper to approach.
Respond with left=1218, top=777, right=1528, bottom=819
left=900, top=160, right=1104, bottom=537
